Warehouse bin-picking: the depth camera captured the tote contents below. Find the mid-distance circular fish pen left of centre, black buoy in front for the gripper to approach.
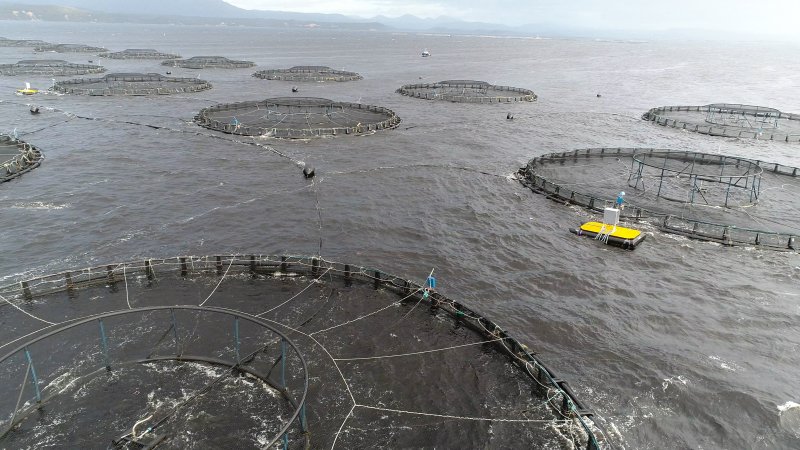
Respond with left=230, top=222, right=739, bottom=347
left=195, top=97, right=400, bottom=138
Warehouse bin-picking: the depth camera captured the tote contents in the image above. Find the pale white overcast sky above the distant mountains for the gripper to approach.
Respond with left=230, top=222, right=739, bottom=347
left=225, top=0, right=800, bottom=35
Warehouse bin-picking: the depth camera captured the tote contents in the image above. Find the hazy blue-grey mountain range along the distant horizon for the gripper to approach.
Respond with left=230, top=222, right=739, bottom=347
left=0, top=0, right=780, bottom=41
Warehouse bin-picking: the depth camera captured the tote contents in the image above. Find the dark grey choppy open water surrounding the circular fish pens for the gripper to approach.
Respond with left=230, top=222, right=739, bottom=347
left=0, top=22, right=800, bottom=448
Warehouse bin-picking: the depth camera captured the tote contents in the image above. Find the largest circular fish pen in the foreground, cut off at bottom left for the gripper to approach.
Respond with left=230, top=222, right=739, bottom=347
left=0, top=255, right=606, bottom=450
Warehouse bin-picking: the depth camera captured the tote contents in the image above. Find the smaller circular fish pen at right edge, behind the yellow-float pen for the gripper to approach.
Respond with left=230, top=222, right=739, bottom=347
left=642, top=103, right=800, bottom=142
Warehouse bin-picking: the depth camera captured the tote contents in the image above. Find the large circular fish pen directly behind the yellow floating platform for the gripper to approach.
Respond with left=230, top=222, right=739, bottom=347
left=518, top=148, right=800, bottom=250
